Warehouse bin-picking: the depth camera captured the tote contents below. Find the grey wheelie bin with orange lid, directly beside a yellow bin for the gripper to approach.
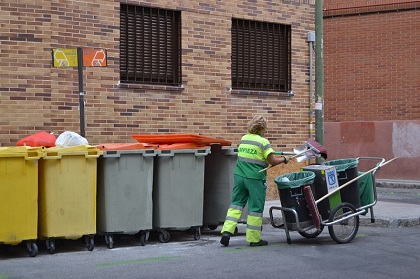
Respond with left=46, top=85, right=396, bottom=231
left=96, top=144, right=156, bottom=249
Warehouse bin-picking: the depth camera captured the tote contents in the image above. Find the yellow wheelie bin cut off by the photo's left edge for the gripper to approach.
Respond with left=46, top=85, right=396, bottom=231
left=0, top=146, right=42, bottom=257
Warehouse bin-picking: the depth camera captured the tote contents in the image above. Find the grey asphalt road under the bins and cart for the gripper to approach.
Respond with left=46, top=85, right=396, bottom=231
left=0, top=224, right=420, bottom=279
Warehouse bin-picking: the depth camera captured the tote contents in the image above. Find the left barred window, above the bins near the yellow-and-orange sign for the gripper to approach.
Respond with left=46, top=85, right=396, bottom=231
left=120, top=4, right=181, bottom=86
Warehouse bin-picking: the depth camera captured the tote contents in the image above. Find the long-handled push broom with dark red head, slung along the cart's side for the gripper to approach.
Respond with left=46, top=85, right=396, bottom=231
left=303, top=157, right=398, bottom=231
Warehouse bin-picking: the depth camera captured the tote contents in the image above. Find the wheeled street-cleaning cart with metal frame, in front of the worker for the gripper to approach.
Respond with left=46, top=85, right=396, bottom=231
left=269, top=157, right=396, bottom=244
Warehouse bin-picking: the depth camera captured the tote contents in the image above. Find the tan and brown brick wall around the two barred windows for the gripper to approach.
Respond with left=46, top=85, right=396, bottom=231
left=0, top=0, right=315, bottom=150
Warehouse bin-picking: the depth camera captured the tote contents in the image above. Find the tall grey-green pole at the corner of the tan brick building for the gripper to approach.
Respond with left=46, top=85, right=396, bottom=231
left=315, top=0, right=324, bottom=163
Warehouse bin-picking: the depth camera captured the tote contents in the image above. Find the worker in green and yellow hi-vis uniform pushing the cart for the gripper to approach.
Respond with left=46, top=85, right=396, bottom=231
left=220, top=115, right=288, bottom=246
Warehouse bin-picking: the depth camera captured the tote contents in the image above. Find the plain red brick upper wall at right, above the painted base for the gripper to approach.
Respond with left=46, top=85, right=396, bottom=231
left=324, top=0, right=420, bottom=122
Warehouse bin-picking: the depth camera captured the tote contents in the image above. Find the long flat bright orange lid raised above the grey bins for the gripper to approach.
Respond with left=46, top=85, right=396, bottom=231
left=131, top=134, right=232, bottom=146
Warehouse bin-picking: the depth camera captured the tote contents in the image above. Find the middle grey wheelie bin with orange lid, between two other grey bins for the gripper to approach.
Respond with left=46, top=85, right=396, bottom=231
left=153, top=144, right=210, bottom=243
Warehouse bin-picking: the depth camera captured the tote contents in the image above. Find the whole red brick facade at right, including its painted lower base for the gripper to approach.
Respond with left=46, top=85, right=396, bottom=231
left=324, top=0, right=420, bottom=181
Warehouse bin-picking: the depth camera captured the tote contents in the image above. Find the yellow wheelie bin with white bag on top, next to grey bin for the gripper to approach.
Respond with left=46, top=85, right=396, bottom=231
left=38, top=145, right=103, bottom=254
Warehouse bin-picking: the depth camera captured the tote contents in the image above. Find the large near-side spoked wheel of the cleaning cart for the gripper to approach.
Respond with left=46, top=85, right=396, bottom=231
left=328, top=202, right=359, bottom=244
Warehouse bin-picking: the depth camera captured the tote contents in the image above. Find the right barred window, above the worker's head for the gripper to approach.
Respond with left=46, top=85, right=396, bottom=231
left=231, top=18, right=291, bottom=92
